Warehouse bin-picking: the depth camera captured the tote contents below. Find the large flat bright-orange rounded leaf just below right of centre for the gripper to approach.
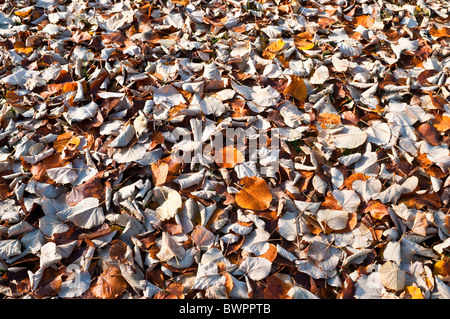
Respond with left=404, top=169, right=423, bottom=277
left=235, top=177, right=272, bottom=211
